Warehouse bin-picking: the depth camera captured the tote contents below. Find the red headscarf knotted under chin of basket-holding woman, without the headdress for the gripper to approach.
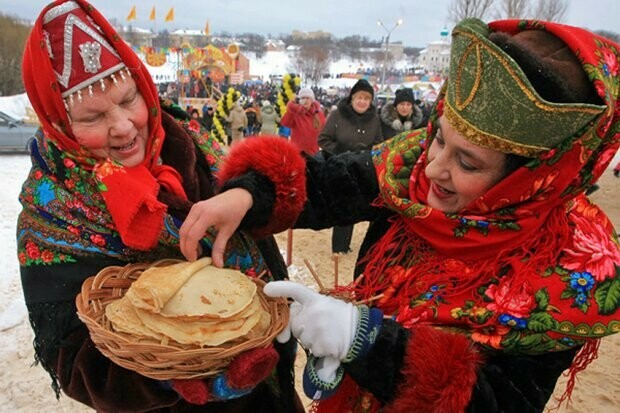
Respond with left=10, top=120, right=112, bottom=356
left=23, top=0, right=185, bottom=250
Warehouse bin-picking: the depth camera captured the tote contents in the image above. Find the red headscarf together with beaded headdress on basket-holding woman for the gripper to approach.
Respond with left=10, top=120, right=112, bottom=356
left=23, top=0, right=186, bottom=250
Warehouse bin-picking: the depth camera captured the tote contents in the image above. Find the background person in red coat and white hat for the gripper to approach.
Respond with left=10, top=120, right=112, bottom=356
left=281, top=87, right=325, bottom=155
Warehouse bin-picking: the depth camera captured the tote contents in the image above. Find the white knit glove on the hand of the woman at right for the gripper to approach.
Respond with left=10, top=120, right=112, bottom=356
left=264, top=281, right=359, bottom=382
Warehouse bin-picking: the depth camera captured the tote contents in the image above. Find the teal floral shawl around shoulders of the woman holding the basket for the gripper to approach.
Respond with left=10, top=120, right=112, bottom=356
left=17, top=115, right=265, bottom=273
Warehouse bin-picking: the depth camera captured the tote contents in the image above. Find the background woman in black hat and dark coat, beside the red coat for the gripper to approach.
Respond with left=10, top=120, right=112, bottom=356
left=319, top=79, right=382, bottom=254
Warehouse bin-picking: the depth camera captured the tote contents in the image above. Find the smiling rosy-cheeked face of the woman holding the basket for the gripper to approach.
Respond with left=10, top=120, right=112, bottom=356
left=69, top=77, right=149, bottom=167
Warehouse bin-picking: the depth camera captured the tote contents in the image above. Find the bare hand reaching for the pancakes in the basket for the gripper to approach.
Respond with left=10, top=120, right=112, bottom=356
left=179, top=188, right=253, bottom=267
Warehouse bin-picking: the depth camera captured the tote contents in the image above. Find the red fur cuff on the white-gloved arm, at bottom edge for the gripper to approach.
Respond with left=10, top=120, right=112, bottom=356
left=385, top=326, right=481, bottom=413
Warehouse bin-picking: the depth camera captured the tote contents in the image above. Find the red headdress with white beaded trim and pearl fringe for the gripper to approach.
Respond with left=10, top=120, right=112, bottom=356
left=43, top=1, right=129, bottom=111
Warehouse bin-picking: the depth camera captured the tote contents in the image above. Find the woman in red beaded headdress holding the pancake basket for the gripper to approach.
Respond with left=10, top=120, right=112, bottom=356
left=17, top=0, right=304, bottom=413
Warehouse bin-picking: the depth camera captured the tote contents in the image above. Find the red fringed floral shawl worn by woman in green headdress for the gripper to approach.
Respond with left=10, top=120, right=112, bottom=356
left=317, top=20, right=620, bottom=411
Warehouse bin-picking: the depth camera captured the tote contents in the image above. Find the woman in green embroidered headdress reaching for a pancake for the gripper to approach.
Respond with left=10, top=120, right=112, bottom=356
left=181, top=19, right=620, bottom=412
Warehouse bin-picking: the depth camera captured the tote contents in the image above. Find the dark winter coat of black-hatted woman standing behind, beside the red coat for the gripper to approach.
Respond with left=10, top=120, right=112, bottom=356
left=319, top=97, right=382, bottom=153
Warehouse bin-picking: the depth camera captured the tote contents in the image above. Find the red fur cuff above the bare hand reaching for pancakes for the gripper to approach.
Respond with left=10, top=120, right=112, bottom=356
left=217, top=137, right=307, bottom=237
